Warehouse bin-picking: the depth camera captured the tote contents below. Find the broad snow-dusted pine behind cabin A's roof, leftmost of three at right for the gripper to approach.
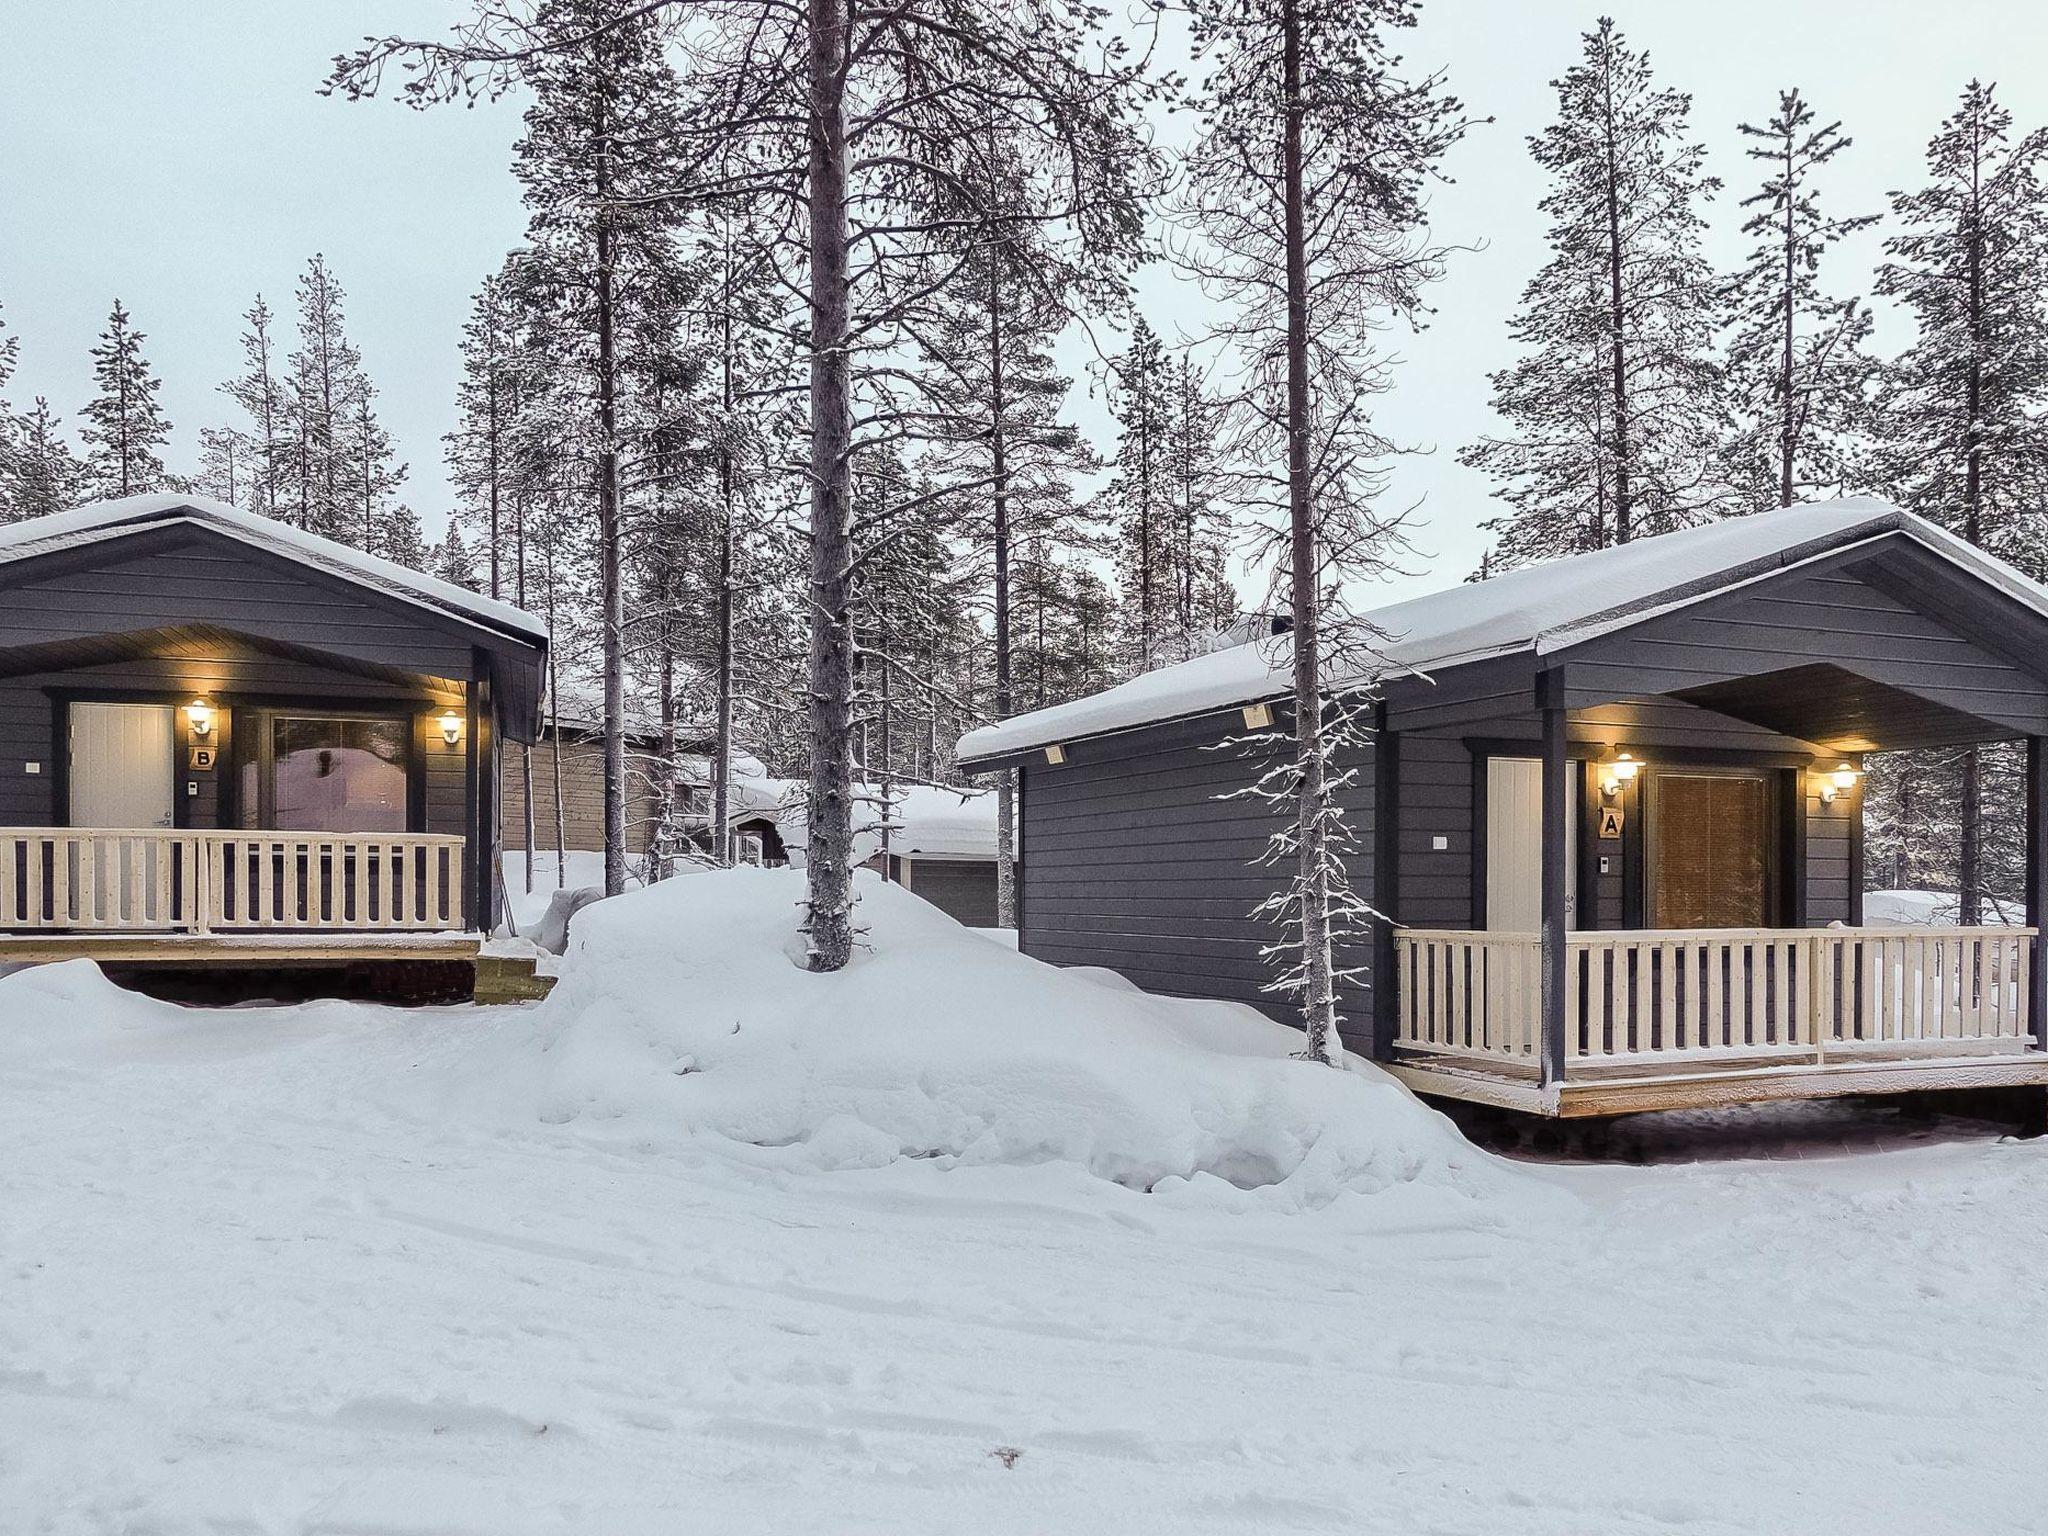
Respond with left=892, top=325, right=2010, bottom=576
left=1458, top=16, right=1724, bottom=569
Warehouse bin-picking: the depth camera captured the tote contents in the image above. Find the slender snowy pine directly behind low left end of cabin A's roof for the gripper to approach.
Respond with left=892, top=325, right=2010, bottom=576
left=1104, top=315, right=1178, bottom=672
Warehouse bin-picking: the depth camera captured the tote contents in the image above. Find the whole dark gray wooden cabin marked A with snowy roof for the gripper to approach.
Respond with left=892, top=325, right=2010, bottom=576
left=961, top=500, right=2048, bottom=1114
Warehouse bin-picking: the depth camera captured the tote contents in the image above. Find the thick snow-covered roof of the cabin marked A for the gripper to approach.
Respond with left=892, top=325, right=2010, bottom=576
left=958, top=496, right=2048, bottom=762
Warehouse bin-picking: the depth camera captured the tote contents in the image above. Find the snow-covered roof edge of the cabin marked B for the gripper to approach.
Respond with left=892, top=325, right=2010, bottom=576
left=0, top=492, right=547, bottom=643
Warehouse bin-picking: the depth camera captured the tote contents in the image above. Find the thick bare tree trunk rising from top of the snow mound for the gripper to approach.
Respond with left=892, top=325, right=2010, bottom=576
left=805, top=0, right=854, bottom=971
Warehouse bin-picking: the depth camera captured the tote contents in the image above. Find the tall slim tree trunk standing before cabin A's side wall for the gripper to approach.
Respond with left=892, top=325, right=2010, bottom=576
left=1280, top=0, right=1341, bottom=1063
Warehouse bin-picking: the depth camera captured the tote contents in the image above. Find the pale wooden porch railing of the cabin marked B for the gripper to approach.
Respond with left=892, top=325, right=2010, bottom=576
left=0, top=827, right=465, bottom=934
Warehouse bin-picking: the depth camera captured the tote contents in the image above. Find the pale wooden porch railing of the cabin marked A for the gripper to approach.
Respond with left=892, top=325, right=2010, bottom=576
left=1395, top=928, right=2034, bottom=1071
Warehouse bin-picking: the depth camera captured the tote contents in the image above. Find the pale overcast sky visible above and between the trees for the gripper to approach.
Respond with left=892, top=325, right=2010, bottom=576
left=0, top=0, right=2048, bottom=602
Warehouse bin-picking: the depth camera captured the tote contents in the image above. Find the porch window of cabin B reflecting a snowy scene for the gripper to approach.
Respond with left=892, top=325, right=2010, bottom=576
left=240, top=711, right=412, bottom=831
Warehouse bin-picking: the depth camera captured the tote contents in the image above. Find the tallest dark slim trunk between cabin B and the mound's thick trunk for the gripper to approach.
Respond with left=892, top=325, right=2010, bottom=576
left=592, top=57, right=627, bottom=897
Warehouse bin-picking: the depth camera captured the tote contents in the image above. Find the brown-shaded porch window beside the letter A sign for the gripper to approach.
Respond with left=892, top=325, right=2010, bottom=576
left=1647, top=772, right=1772, bottom=928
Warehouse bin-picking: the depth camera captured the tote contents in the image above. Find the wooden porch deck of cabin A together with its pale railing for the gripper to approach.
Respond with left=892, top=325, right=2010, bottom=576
left=1389, top=928, right=2048, bottom=1116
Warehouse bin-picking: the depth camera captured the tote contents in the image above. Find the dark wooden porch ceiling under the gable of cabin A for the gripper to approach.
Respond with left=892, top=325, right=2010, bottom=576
left=1671, top=662, right=2013, bottom=752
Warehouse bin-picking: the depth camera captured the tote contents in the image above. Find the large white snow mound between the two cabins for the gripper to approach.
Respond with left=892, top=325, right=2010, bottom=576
left=487, top=870, right=1497, bottom=1206
